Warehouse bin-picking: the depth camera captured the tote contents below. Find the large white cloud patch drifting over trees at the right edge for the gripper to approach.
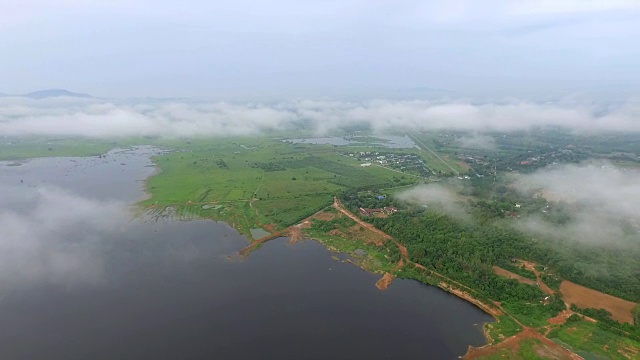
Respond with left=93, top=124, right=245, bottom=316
left=517, top=161, right=640, bottom=246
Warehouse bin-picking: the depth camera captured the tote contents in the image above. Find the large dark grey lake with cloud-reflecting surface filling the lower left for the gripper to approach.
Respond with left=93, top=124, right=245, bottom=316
left=0, top=148, right=492, bottom=359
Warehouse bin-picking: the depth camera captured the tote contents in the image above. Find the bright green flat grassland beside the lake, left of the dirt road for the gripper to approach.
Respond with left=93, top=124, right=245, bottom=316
left=143, top=137, right=416, bottom=235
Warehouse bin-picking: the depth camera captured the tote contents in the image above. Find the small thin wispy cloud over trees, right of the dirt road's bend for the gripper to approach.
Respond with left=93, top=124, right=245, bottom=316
left=395, top=184, right=471, bottom=221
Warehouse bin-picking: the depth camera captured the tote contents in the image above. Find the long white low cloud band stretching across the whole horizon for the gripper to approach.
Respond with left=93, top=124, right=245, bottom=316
left=0, top=98, right=640, bottom=138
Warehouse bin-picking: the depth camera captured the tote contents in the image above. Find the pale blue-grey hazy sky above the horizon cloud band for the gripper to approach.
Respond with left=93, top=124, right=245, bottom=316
left=0, top=0, right=640, bottom=97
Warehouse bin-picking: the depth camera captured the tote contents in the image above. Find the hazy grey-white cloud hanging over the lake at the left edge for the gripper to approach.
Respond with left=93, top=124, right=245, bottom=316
left=0, top=184, right=128, bottom=287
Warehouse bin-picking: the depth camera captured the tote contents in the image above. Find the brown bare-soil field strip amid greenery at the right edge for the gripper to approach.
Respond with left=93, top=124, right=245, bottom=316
left=560, top=280, right=636, bottom=324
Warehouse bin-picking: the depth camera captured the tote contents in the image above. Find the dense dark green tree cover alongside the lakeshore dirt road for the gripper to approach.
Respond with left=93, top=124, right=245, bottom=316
left=347, top=202, right=564, bottom=326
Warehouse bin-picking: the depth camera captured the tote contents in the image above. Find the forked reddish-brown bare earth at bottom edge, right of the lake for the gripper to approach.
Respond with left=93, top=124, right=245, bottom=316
left=464, top=327, right=582, bottom=360
